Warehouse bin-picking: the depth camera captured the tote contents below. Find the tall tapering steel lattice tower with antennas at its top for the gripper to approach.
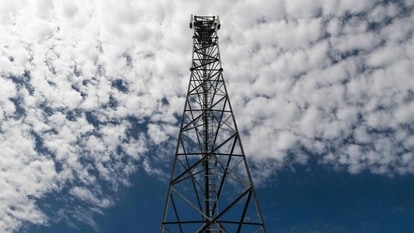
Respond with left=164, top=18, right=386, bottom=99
left=161, top=16, right=266, bottom=233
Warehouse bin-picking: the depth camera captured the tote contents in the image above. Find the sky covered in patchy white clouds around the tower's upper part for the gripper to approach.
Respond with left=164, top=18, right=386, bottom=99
left=0, top=0, right=414, bottom=232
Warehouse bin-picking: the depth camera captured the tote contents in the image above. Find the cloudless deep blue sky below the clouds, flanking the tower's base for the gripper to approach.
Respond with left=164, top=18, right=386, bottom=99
left=30, top=160, right=414, bottom=233
